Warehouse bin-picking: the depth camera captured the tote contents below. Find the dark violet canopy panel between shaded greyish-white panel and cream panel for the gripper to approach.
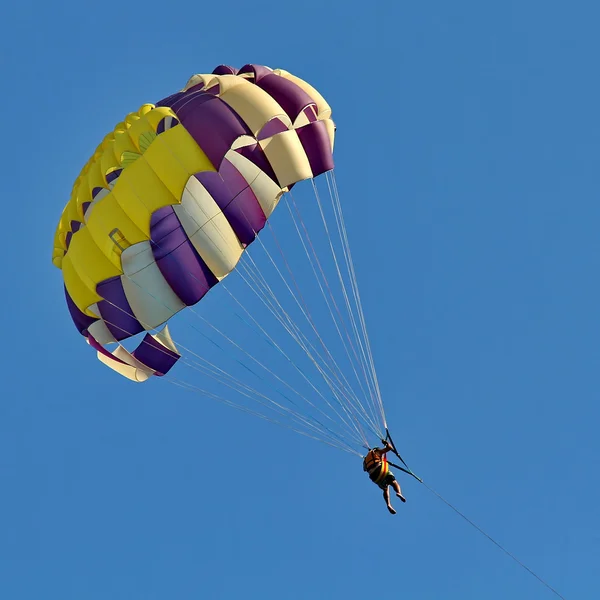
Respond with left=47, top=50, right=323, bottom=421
left=150, top=206, right=218, bottom=306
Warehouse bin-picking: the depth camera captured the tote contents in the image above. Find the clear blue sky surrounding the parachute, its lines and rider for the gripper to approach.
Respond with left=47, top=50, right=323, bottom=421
left=0, top=0, right=600, bottom=600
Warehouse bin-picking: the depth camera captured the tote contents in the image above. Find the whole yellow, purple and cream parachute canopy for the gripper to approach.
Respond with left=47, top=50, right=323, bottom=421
left=53, top=65, right=335, bottom=381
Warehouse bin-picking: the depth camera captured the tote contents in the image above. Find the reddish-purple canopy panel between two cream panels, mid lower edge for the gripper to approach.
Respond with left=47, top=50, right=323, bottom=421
left=195, top=160, right=266, bottom=245
